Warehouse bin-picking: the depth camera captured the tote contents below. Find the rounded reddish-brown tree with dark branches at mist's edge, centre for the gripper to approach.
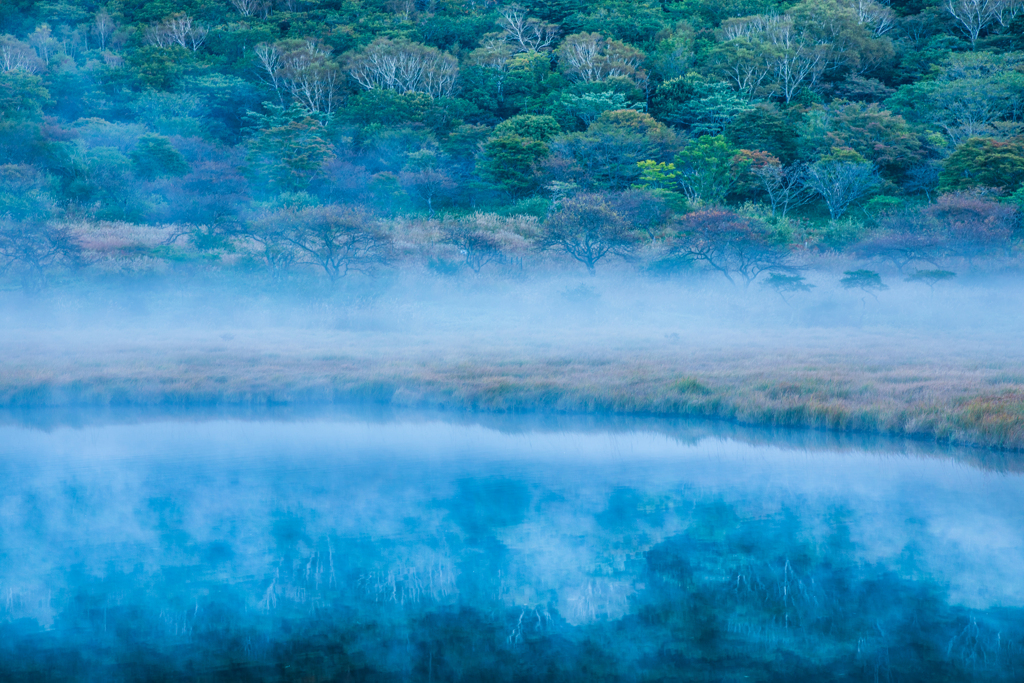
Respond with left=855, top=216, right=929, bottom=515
left=540, top=194, right=637, bottom=275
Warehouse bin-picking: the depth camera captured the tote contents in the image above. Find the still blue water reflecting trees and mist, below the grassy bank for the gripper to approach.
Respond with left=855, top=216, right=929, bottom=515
left=0, top=412, right=1024, bottom=682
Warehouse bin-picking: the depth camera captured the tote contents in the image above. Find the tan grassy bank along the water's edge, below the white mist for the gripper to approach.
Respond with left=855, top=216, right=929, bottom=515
left=0, top=339, right=1024, bottom=451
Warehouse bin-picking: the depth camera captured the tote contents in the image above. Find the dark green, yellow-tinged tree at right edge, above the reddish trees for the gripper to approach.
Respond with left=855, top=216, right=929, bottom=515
left=939, top=137, right=1024, bottom=191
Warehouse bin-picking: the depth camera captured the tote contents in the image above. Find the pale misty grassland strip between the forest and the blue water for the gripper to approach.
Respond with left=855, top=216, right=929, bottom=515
left=0, top=261, right=1024, bottom=450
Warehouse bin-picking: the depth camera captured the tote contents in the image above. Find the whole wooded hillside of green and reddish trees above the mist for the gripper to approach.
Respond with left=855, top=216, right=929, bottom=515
left=0, top=0, right=1024, bottom=286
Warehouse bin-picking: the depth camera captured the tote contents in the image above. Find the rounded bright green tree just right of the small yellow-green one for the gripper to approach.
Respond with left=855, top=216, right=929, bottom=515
left=675, top=135, right=751, bottom=206
